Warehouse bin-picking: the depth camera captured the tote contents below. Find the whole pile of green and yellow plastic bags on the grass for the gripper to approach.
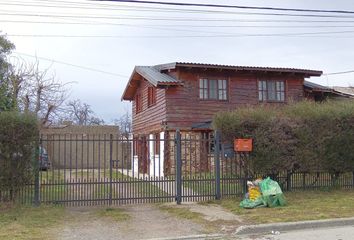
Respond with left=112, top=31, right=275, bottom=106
left=240, top=177, right=286, bottom=208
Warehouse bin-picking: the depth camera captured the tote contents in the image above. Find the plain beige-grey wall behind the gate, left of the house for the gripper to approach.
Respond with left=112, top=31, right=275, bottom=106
left=41, top=125, right=131, bottom=169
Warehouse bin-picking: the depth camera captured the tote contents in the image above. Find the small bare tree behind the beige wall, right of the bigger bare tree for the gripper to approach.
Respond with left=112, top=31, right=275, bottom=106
left=65, top=99, right=104, bottom=125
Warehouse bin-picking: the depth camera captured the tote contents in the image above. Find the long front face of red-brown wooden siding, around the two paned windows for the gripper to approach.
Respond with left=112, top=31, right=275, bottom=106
left=166, top=70, right=303, bottom=129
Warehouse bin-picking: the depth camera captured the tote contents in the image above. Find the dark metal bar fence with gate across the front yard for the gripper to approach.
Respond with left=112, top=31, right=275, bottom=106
left=0, top=131, right=354, bottom=206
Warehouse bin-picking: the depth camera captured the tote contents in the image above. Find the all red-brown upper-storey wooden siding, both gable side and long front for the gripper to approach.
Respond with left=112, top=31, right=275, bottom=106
left=132, top=68, right=304, bottom=135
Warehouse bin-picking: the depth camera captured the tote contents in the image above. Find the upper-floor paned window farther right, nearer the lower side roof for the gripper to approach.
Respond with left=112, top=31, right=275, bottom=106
left=258, top=80, right=285, bottom=102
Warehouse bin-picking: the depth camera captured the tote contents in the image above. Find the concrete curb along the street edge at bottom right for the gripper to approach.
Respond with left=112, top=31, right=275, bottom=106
left=234, top=217, right=354, bottom=235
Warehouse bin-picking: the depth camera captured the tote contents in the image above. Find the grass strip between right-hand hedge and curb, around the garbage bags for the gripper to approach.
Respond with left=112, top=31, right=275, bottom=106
left=217, top=190, right=354, bottom=224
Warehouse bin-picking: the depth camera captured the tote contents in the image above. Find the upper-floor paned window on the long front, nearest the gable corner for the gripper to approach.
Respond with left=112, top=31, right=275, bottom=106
left=199, top=79, right=228, bottom=100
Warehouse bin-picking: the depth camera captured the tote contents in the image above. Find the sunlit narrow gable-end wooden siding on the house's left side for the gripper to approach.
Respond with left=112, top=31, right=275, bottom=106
left=132, top=79, right=166, bottom=134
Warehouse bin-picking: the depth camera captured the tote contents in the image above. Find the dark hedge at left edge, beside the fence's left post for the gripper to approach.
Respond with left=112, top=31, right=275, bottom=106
left=0, top=112, right=38, bottom=201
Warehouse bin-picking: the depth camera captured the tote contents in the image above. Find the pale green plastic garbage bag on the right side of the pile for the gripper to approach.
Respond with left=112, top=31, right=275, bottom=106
left=259, top=177, right=286, bottom=207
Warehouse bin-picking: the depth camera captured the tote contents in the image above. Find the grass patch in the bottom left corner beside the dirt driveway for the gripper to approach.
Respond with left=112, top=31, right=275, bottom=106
left=0, top=206, right=64, bottom=240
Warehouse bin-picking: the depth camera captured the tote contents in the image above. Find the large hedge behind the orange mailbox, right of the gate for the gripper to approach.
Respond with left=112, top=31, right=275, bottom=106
left=213, top=101, right=354, bottom=173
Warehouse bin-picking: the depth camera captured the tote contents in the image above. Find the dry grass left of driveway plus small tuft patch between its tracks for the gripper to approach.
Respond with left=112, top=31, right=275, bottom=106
left=0, top=205, right=130, bottom=240
